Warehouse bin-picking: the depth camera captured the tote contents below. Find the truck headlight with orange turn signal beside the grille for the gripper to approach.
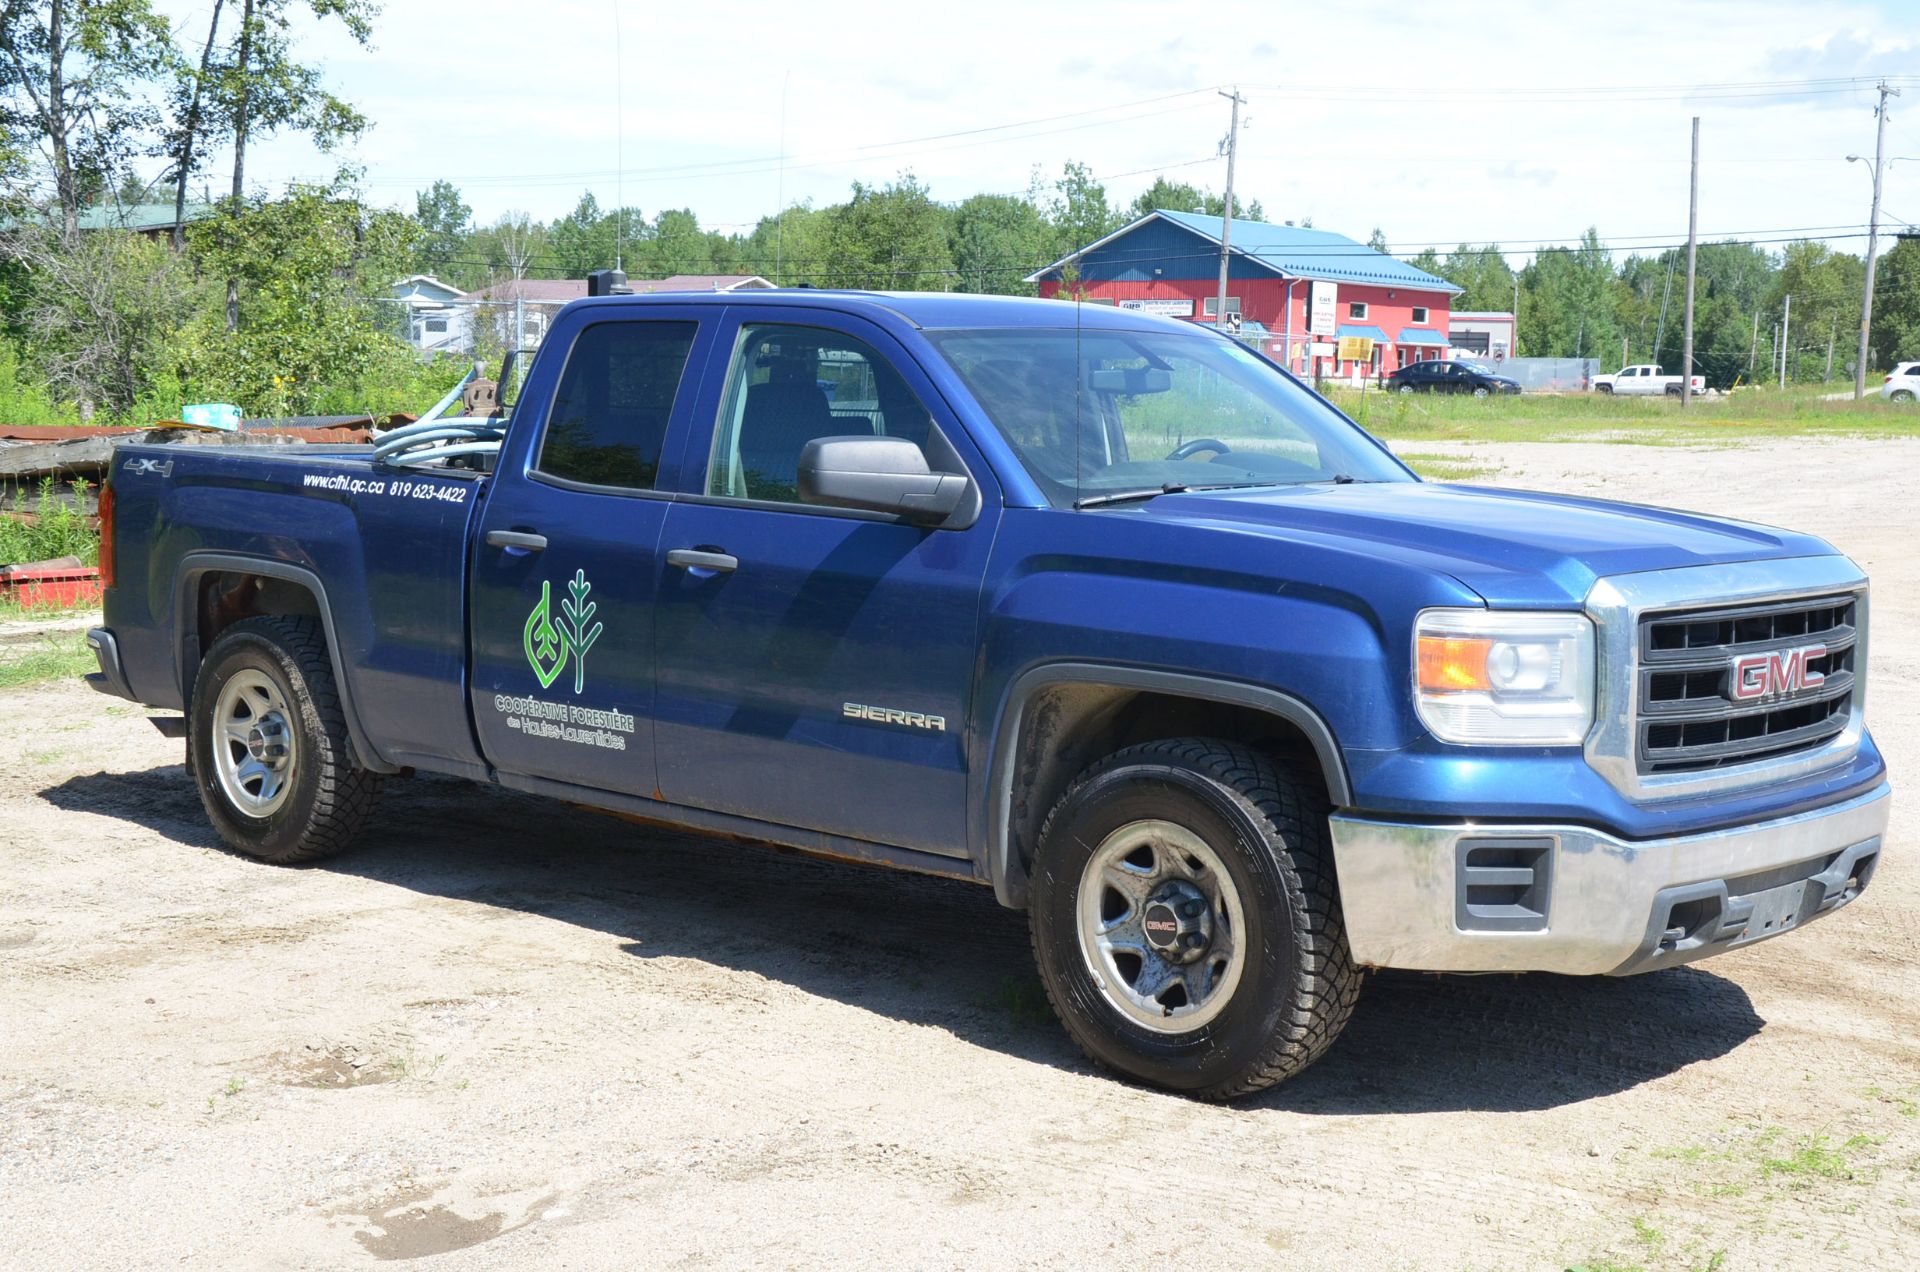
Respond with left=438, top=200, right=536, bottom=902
left=1413, top=609, right=1594, bottom=746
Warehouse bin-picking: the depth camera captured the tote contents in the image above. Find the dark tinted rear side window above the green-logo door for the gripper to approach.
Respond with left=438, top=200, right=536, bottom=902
left=534, top=319, right=695, bottom=490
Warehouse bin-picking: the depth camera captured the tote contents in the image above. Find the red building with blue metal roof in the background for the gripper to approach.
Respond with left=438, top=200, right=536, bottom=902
left=1027, top=211, right=1461, bottom=380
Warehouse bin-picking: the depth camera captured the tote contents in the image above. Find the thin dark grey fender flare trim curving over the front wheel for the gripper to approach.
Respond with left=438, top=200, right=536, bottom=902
left=985, top=663, right=1354, bottom=909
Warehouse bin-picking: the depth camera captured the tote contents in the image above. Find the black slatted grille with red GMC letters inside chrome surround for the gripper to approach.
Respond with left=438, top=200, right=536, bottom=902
left=1634, top=594, right=1859, bottom=774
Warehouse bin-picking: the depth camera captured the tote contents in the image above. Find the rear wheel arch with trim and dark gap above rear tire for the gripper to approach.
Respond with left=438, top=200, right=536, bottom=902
left=173, top=551, right=399, bottom=772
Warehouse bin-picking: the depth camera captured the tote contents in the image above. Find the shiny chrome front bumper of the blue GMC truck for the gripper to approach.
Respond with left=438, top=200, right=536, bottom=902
left=1331, top=784, right=1891, bottom=976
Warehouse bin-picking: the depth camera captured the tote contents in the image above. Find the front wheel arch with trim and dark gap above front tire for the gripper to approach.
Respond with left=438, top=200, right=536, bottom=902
left=985, top=663, right=1352, bottom=909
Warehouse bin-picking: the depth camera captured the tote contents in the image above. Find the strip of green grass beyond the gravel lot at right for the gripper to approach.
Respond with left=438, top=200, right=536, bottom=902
left=1331, top=382, right=1920, bottom=446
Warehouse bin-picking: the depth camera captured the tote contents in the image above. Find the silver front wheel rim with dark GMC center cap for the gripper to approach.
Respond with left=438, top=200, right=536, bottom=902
left=1075, top=820, right=1246, bottom=1034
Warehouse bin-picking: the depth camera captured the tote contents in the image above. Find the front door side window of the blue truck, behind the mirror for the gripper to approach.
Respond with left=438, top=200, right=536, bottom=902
left=707, top=323, right=941, bottom=503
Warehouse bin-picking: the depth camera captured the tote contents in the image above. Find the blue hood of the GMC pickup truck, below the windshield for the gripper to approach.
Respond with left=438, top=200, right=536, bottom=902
left=1137, top=482, right=1834, bottom=607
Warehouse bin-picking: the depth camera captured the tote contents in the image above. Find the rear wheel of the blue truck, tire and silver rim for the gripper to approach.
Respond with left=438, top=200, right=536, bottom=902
left=186, top=617, right=380, bottom=865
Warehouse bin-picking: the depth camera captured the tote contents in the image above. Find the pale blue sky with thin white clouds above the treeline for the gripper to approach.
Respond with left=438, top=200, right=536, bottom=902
left=159, top=0, right=1920, bottom=261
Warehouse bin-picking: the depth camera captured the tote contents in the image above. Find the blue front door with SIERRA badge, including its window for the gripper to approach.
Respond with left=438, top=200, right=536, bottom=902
left=655, top=307, right=998, bottom=857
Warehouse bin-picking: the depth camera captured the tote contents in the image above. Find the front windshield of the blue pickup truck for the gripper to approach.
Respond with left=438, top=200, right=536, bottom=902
left=927, top=329, right=1413, bottom=505
